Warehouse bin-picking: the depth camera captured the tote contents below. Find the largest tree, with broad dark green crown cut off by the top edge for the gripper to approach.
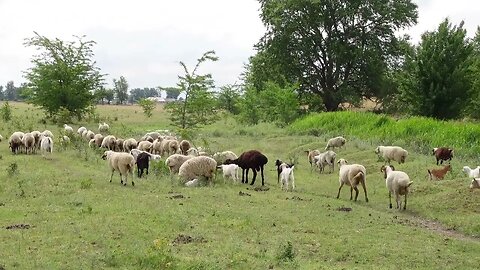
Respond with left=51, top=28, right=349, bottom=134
left=251, top=0, right=417, bottom=111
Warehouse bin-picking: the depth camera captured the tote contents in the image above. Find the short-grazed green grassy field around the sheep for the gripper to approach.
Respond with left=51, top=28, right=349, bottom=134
left=0, top=103, right=480, bottom=269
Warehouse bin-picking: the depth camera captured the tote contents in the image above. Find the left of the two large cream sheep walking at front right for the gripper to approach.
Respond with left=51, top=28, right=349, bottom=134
left=337, top=158, right=368, bottom=202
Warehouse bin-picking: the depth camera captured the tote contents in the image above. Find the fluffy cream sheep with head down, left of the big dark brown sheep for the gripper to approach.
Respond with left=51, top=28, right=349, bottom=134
left=178, top=156, right=217, bottom=184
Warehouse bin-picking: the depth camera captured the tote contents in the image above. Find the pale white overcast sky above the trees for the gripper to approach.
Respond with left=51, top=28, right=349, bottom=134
left=0, top=0, right=480, bottom=88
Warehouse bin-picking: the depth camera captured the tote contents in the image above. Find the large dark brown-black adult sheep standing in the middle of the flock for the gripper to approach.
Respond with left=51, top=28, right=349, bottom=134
left=225, top=150, right=268, bottom=186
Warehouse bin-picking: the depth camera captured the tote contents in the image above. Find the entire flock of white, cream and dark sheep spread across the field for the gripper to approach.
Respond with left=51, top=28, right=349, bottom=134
left=0, top=123, right=480, bottom=209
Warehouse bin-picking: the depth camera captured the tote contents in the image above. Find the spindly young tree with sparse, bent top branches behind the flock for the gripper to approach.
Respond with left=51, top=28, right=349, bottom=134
left=165, top=51, right=218, bottom=130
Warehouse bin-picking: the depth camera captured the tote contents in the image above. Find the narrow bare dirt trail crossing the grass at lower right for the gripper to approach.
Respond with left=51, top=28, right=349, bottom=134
left=392, top=216, right=480, bottom=242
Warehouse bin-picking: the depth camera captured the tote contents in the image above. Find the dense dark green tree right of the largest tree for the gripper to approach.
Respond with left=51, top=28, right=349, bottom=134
left=405, top=19, right=473, bottom=119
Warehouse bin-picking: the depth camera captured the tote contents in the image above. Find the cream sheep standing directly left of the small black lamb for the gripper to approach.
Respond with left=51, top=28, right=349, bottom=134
left=102, top=150, right=135, bottom=186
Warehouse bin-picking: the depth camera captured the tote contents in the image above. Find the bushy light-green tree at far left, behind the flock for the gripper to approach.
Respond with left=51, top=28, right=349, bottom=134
left=24, top=32, right=104, bottom=119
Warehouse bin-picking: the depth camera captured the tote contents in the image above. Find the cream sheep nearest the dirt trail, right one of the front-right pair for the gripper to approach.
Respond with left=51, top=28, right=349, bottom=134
left=380, top=166, right=413, bottom=210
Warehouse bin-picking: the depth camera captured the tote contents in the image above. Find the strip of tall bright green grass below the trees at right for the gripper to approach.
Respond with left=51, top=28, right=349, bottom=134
left=289, top=111, right=480, bottom=157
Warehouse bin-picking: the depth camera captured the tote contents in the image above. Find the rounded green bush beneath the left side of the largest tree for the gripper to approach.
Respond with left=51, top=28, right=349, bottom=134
left=239, top=82, right=300, bottom=126
